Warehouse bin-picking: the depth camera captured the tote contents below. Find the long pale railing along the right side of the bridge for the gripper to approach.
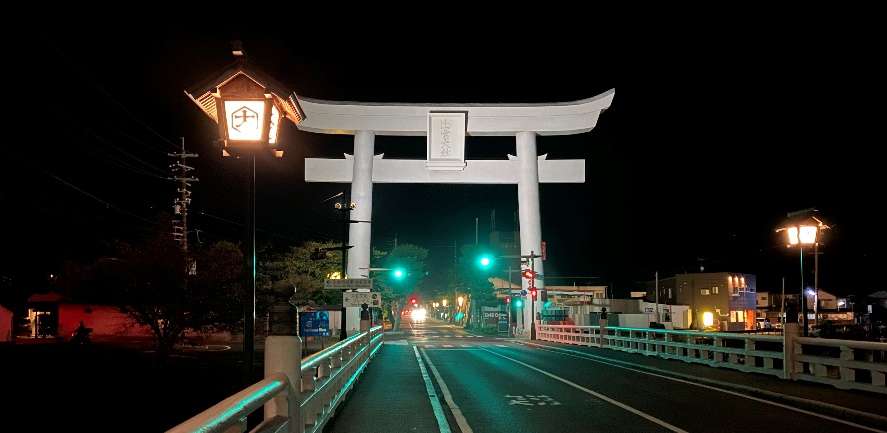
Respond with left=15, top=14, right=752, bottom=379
left=536, top=324, right=887, bottom=394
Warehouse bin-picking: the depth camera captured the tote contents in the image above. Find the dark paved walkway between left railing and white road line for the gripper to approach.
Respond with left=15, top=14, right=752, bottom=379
left=324, top=342, right=438, bottom=433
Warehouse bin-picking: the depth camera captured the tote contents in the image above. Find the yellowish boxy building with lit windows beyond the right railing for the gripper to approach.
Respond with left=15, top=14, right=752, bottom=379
left=646, top=272, right=756, bottom=331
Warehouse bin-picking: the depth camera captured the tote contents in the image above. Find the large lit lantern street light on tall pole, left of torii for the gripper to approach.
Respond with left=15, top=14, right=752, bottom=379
left=185, top=42, right=304, bottom=380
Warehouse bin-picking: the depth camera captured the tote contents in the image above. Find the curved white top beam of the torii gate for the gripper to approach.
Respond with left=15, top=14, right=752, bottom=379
left=293, top=89, right=616, bottom=136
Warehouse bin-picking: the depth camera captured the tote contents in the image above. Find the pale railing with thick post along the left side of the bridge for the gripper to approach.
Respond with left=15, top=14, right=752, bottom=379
left=167, top=326, right=382, bottom=433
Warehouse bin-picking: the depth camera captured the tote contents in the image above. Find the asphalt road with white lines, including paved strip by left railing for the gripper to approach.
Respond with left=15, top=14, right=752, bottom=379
left=326, top=322, right=880, bottom=433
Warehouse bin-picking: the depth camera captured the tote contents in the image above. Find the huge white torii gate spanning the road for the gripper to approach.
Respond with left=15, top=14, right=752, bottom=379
left=294, top=89, right=616, bottom=333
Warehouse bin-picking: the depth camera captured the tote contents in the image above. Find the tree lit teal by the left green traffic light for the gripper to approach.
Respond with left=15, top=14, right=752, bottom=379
left=374, top=244, right=428, bottom=330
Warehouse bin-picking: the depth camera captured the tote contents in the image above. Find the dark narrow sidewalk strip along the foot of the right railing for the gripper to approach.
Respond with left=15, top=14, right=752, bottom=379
left=516, top=340, right=887, bottom=427
